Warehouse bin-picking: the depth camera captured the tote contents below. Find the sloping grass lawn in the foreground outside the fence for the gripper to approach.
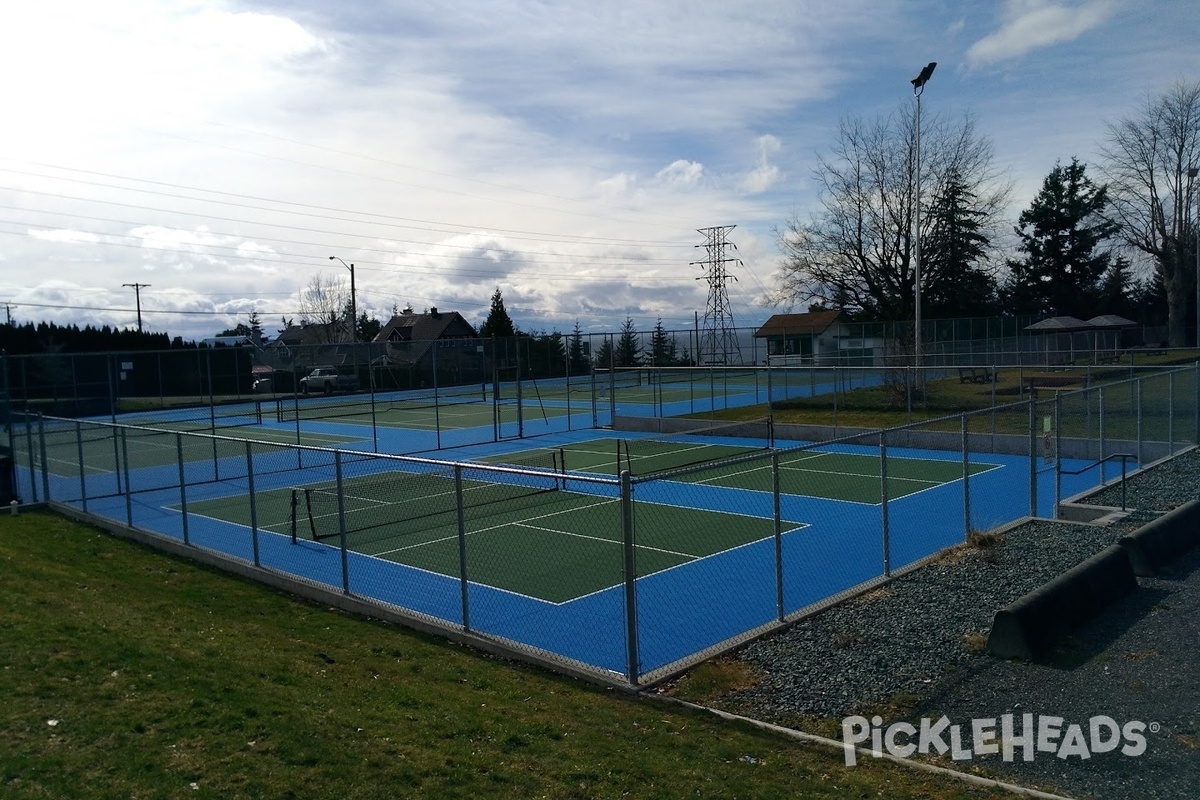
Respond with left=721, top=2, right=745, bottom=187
left=0, top=512, right=1012, bottom=799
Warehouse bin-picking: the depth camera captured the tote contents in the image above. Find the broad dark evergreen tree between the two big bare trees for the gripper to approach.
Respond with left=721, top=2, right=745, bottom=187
left=1001, top=158, right=1118, bottom=319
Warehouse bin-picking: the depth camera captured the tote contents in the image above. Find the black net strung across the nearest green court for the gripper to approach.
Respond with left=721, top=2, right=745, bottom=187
left=290, top=455, right=563, bottom=541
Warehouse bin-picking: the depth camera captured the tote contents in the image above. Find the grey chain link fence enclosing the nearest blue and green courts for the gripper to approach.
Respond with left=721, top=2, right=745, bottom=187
left=7, top=366, right=1200, bottom=685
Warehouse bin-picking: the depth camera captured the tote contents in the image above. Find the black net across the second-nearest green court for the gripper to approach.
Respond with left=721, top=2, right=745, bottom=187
left=617, top=417, right=775, bottom=475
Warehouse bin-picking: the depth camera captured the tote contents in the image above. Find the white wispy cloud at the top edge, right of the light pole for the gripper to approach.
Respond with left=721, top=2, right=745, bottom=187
left=966, top=0, right=1116, bottom=66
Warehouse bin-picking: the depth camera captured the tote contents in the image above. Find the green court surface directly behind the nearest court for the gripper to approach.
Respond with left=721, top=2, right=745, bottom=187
left=496, top=438, right=998, bottom=504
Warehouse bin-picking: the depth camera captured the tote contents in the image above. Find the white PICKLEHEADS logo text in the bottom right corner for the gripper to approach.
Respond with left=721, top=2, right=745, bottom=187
left=841, top=714, right=1159, bottom=766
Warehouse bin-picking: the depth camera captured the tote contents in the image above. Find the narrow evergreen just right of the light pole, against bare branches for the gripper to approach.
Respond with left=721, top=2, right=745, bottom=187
left=920, top=170, right=996, bottom=319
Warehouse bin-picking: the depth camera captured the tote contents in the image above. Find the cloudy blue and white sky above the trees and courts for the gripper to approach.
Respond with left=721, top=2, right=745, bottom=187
left=0, top=0, right=1200, bottom=338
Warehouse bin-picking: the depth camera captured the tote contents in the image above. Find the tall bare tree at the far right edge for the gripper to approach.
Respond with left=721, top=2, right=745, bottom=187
left=1100, top=79, right=1200, bottom=347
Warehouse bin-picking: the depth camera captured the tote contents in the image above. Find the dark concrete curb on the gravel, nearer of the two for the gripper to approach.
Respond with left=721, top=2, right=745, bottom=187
left=988, top=545, right=1138, bottom=661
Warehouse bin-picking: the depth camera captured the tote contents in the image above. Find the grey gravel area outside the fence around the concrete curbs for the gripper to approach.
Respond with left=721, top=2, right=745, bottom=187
left=700, top=452, right=1200, bottom=800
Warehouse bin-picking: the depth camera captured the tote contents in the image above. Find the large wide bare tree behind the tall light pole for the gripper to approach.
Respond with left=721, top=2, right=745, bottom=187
left=768, top=106, right=1009, bottom=319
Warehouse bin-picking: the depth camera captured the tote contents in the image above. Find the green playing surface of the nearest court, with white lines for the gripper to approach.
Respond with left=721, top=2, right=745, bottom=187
left=177, top=473, right=804, bottom=602
